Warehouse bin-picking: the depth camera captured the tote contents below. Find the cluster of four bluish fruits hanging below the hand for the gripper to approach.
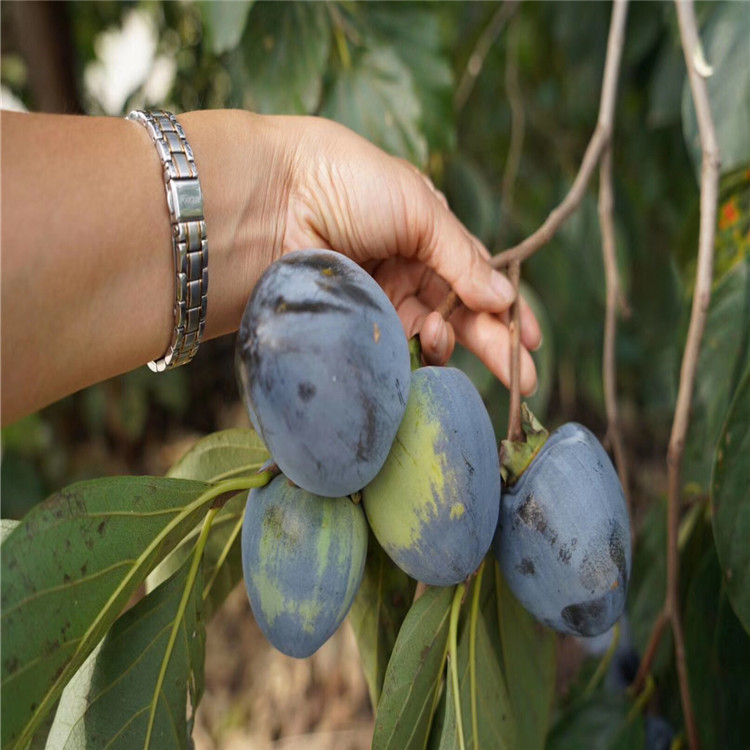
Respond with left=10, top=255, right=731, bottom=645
left=237, top=250, right=630, bottom=657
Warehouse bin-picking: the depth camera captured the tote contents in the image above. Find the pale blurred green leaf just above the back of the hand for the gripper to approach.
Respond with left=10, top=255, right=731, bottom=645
left=321, top=45, right=427, bottom=166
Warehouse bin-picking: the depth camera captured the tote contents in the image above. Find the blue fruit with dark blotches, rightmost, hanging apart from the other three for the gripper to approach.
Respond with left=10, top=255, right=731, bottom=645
left=493, top=423, right=631, bottom=636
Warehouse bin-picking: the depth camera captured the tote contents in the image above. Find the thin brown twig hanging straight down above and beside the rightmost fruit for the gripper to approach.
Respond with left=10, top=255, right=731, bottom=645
left=599, top=145, right=633, bottom=529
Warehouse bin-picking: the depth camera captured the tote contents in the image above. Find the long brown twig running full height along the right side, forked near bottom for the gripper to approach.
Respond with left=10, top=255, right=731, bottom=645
left=637, top=0, right=721, bottom=750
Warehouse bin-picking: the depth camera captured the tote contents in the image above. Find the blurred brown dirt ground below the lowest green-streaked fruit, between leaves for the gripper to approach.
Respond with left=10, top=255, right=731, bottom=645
left=193, top=585, right=373, bottom=750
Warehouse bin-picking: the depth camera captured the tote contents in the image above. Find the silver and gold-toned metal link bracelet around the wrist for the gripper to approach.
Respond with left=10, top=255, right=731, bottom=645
left=127, top=110, right=208, bottom=372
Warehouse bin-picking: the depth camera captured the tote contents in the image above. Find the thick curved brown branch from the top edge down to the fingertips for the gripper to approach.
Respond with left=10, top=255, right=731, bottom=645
left=438, top=0, right=628, bottom=320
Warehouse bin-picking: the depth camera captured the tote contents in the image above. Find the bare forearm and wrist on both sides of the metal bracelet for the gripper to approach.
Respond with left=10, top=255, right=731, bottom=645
left=2, top=112, right=286, bottom=424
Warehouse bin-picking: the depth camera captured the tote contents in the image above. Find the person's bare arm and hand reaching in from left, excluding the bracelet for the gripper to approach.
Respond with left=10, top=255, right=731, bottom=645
left=2, top=111, right=539, bottom=424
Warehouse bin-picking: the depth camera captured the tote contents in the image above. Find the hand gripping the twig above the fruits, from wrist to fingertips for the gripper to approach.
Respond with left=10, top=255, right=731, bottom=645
left=276, top=118, right=541, bottom=395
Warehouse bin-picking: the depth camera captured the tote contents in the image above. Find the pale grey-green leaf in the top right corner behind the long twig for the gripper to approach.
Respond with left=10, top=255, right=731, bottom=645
left=682, top=3, right=750, bottom=177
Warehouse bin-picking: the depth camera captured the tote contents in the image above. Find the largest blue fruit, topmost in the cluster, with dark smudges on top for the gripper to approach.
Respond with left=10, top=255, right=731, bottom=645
left=237, top=250, right=411, bottom=497
